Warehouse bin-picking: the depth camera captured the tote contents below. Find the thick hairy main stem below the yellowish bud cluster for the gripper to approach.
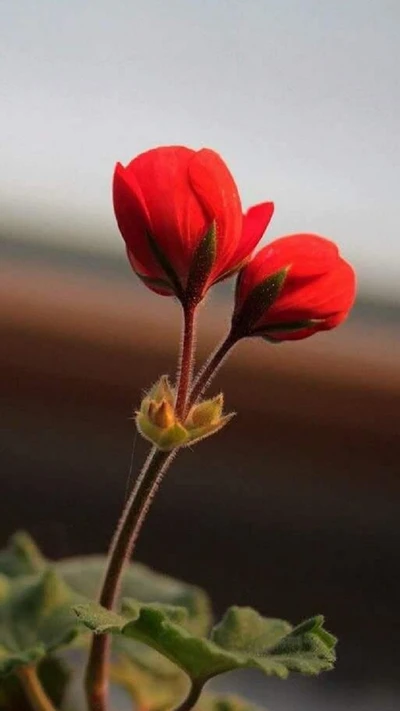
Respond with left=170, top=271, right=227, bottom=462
left=86, top=447, right=174, bottom=711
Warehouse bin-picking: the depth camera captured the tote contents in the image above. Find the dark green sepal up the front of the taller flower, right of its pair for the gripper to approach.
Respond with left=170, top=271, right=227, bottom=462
left=186, top=221, right=217, bottom=304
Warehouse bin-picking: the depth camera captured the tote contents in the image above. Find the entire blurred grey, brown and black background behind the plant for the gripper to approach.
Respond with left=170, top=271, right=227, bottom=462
left=0, top=0, right=400, bottom=711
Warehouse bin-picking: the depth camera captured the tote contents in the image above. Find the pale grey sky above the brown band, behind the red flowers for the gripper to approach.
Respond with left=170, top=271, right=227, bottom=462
left=0, top=0, right=400, bottom=300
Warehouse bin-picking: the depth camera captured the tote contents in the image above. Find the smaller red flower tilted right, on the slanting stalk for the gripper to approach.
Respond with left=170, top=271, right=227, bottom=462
left=232, top=234, right=355, bottom=341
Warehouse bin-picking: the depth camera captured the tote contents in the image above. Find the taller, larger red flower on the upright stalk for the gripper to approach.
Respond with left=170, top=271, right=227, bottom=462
left=113, top=146, right=273, bottom=302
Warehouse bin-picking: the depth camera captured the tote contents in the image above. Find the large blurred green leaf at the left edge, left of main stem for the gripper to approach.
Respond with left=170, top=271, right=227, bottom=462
left=0, top=569, right=82, bottom=676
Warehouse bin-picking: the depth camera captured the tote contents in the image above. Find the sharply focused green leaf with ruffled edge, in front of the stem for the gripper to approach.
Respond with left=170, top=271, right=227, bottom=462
left=74, top=600, right=336, bottom=683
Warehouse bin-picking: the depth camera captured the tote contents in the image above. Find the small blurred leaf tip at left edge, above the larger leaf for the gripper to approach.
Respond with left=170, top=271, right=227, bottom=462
left=0, top=531, right=47, bottom=578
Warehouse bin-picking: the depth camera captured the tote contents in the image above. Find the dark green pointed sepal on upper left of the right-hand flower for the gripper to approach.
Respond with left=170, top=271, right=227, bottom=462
left=232, top=267, right=290, bottom=338
